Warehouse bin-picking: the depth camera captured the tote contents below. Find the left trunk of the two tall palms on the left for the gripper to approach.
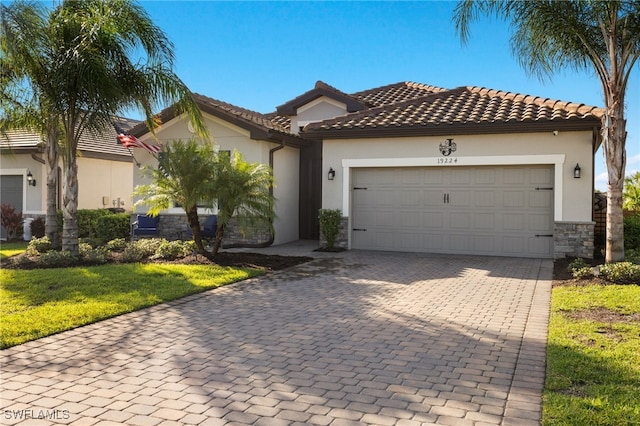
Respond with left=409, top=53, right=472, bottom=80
left=44, top=128, right=60, bottom=248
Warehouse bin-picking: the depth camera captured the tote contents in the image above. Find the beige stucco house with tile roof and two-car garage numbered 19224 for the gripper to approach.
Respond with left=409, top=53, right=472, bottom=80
left=132, top=82, right=603, bottom=258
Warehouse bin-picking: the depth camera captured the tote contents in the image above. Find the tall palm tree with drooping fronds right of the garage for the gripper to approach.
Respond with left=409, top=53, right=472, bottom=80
left=454, top=0, right=640, bottom=263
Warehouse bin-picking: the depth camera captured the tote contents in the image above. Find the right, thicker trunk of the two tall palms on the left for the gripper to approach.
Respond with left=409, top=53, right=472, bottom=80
left=62, top=152, right=79, bottom=256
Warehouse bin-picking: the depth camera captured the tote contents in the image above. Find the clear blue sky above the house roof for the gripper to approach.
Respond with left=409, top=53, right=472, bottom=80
left=141, top=1, right=640, bottom=190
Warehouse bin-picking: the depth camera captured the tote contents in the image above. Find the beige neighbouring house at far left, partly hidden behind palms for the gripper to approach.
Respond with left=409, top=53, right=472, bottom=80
left=0, top=118, right=138, bottom=238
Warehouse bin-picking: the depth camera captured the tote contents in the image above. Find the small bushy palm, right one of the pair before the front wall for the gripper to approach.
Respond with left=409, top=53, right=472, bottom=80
left=212, top=150, right=275, bottom=256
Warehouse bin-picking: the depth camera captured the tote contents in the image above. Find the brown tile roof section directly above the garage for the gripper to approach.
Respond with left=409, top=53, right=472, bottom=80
left=304, top=86, right=603, bottom=133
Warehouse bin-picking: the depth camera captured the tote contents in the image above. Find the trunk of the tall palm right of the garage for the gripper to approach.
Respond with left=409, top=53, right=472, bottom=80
left=603, top=91, right=627, bottom=263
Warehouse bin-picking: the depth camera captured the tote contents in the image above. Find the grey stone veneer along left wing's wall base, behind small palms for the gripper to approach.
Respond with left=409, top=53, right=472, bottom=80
left=131, top=214, right=271, bottom=247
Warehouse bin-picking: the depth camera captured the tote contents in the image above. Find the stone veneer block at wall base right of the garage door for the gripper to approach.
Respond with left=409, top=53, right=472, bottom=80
left=553, top=222, right=596, bottom=259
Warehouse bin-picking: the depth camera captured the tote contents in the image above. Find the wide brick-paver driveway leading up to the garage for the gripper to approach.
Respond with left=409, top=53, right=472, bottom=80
left=0, top=251, right=551, bottom=425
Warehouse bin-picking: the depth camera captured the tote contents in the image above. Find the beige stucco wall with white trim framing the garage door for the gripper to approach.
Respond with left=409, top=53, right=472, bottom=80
left=322, top=132, right=593, bottom=222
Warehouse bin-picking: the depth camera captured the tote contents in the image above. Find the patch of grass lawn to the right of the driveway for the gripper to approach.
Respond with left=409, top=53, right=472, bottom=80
left=543, top=284, right=640, bottom=426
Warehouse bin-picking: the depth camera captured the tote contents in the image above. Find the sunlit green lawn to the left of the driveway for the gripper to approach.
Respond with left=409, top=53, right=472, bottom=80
left=0, top=262, right=262, bottom=348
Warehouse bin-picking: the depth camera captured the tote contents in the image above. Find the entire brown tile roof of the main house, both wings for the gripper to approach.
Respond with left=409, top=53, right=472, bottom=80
left=131, top=81, right=603, bottom=138
